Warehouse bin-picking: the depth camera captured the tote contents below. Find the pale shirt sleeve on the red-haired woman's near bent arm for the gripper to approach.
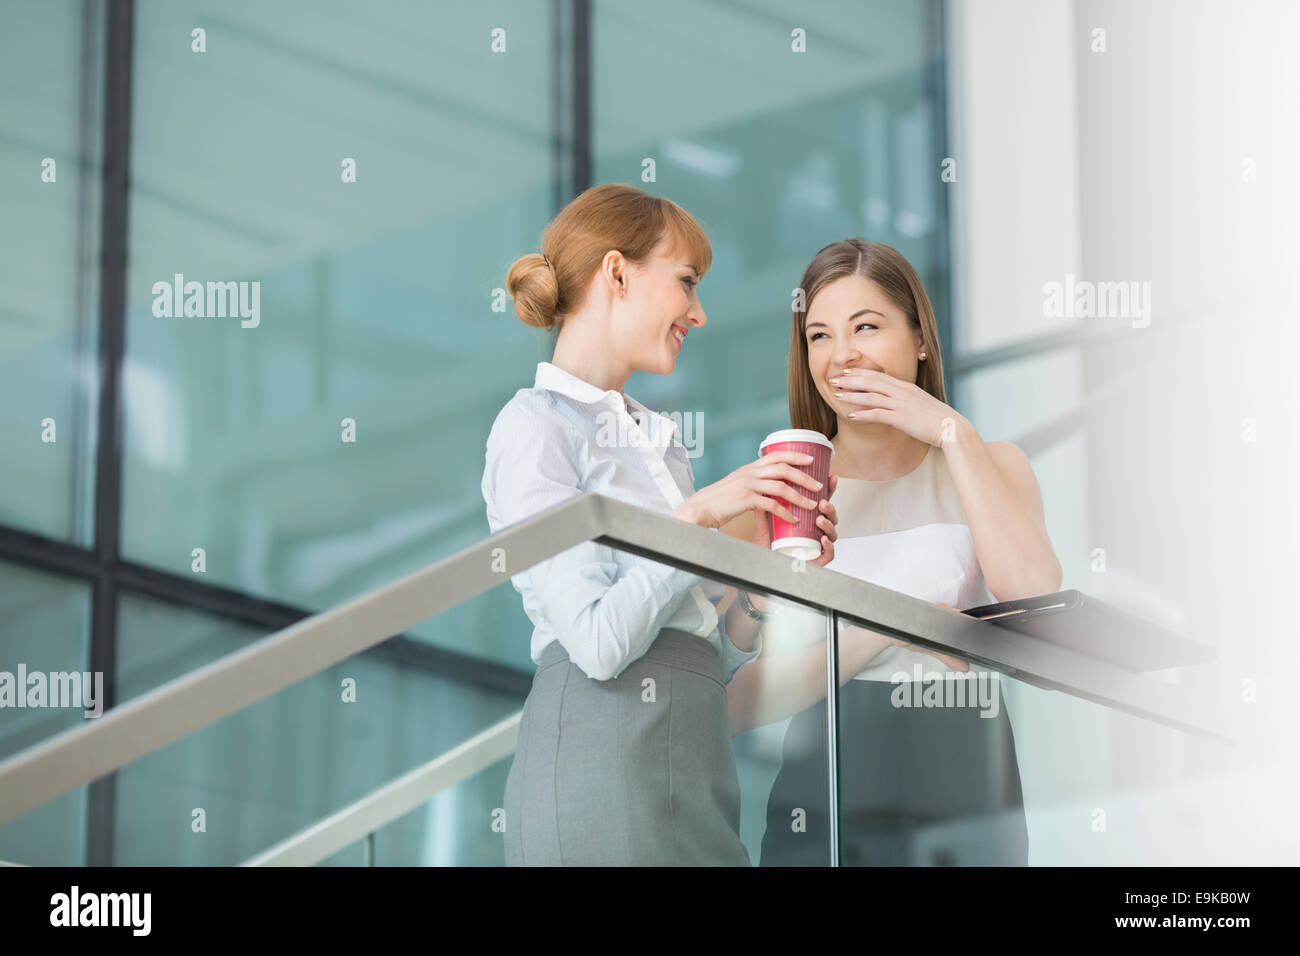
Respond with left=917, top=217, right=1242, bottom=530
left=482, top=405, right=702, bottom=680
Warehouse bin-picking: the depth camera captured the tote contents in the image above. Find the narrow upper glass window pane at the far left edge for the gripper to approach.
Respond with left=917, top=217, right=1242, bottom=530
left=0, top=0, right=105, bottom=545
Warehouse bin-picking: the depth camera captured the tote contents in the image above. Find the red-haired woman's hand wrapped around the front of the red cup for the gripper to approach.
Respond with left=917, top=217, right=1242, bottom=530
left=672, top=451, right=828, bottom=528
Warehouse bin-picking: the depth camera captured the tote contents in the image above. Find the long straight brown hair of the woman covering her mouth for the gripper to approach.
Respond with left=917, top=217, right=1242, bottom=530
left=789, top=239, right=948, bottom=438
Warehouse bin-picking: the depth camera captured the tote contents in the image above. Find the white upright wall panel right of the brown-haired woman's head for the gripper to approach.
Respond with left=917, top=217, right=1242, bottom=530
left=946, top=3, right=1086, bottom=354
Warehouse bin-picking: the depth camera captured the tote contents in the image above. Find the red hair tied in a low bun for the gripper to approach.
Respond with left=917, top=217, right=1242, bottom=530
left=506, top=182, right=714, bottom=329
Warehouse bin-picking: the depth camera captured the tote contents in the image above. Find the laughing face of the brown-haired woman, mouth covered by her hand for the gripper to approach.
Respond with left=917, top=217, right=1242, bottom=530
left=803, top=276, right=922, bottom=424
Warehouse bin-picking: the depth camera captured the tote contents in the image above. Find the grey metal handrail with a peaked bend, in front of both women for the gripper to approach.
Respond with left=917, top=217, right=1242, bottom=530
left=0, top=493, right=1244, bottom=823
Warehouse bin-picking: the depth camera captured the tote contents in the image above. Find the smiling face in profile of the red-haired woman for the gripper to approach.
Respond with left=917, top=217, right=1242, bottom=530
left=615, top=243, right=707, bottom=375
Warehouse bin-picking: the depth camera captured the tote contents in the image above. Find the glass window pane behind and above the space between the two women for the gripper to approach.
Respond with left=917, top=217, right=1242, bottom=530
left=592, top=0, right=948, bottom=486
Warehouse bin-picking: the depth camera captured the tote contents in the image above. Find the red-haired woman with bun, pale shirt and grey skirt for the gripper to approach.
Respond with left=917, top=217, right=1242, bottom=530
left=482, top=183, right=836, bottom=865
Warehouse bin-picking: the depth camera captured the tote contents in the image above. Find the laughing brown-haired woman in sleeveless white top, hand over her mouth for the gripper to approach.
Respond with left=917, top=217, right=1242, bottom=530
left=724, top=239, right=1061, bottom=865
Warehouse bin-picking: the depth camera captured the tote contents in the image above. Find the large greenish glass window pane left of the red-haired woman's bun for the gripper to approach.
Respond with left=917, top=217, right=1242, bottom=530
left=122, top=0, right=554, bottom=681
